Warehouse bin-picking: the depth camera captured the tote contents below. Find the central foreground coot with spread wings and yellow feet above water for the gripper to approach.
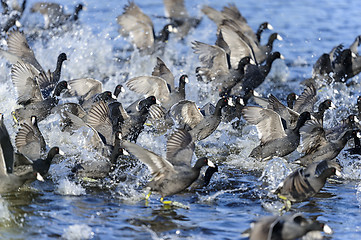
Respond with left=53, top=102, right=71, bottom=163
left=121, top=130, right=215, bottom=204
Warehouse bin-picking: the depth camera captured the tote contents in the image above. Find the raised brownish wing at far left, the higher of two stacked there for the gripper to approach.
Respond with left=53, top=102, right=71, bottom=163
left=7, top=31, right=44, bottom=72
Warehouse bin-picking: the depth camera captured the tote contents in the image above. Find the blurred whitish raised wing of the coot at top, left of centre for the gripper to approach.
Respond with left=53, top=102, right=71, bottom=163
left=117, top=2, right=154, bottom=49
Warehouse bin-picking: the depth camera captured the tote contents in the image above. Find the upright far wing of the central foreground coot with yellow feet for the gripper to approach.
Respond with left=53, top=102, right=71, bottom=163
left=166, top=130, right=195, bottom=166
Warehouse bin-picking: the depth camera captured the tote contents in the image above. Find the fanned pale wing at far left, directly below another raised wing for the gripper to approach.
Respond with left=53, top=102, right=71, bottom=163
left=11, top=62, right=43, bottom=104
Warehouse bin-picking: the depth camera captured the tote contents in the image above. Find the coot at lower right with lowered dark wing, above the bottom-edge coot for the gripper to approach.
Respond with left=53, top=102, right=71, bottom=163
left=274, top=160, right=341, bottom=206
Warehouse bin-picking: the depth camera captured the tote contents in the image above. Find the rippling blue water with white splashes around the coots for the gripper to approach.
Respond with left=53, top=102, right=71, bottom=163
left=0, top=0, right=361, bottom=239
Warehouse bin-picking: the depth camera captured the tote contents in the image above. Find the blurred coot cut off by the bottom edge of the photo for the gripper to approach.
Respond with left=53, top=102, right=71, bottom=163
left=245, top=213, right=333, bottom=240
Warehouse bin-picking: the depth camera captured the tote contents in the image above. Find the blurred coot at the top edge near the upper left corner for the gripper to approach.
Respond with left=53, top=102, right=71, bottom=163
left=30, top=2, right=84, bottom=29
